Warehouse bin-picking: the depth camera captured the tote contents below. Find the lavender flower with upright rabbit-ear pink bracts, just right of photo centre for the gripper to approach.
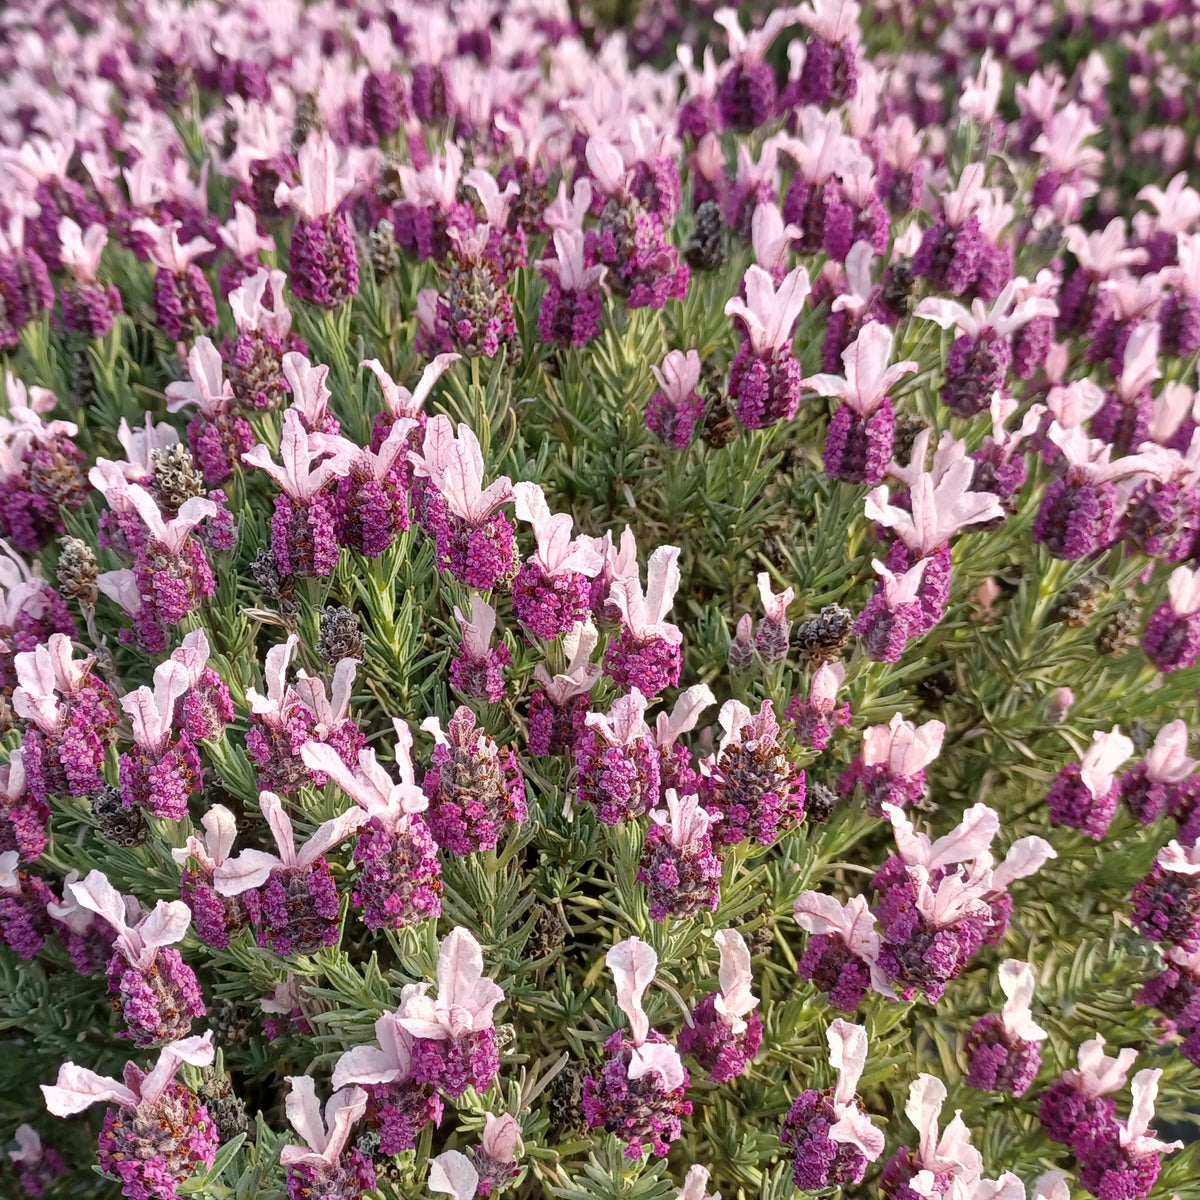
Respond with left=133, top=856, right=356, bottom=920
left=604, top=538, right=683, bottom=697
